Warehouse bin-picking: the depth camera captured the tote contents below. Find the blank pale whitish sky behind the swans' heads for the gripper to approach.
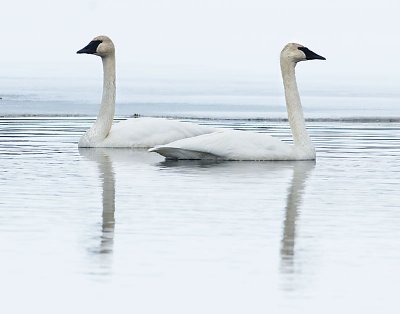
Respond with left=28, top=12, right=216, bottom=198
left=0, top=0, right=400, bottom=87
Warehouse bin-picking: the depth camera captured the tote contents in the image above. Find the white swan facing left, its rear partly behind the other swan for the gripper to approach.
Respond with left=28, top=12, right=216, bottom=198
left=77, top=36, right=215, bottom=148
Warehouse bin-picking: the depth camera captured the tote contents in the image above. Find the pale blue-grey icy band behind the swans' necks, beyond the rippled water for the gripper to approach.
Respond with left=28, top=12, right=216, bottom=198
left=0, top=73, right=400, bottom=121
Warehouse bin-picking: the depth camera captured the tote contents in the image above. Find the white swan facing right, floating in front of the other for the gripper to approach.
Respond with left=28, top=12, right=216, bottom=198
left=149, top=43, right=326, bottom=160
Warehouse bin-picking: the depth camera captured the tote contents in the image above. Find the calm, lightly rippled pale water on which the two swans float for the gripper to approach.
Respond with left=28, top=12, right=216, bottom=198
left=0, top=118, right=400, bottom=314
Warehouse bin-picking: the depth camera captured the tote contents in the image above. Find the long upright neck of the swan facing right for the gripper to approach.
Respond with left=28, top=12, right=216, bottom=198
left=281, top=58, right=314, bottom=149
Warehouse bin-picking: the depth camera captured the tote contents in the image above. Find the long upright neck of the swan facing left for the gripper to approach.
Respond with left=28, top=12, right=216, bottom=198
left=92, top=53, right=115, bottom=139
